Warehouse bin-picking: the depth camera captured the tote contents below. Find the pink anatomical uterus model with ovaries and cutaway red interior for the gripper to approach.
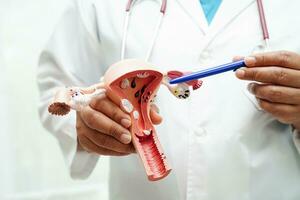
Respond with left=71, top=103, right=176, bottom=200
left=48, top=59, right=202, bottom=181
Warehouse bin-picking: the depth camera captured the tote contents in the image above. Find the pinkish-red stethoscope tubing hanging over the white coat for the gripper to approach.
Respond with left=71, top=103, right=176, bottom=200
left=121, top=0, right=270, bottom=61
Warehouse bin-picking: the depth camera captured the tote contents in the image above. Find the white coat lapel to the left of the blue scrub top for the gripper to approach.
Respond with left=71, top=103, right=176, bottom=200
left=176, top=0, right=208, bottom=35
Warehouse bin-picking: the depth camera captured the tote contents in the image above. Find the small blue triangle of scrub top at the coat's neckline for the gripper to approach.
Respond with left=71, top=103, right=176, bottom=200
left=199, top=0, right=222, bottom=24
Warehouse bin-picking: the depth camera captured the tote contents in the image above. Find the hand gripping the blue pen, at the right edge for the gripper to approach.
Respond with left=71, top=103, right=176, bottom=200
left=234, top=51, right=300, bottom=131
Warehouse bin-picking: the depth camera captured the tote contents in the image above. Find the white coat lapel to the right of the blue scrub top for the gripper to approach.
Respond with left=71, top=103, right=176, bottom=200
left=200, top=0, right=255, bottom=52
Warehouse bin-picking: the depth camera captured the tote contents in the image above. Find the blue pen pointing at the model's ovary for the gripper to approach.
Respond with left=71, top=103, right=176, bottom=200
left=170, top=60, right=246, bottom=84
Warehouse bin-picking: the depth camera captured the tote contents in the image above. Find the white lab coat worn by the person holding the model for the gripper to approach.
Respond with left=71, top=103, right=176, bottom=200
left=38, top=0, right=300, bottom=200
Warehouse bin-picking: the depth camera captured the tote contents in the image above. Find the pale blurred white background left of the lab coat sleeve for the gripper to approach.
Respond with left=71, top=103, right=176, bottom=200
left=0, top=0, right=108, bottom=200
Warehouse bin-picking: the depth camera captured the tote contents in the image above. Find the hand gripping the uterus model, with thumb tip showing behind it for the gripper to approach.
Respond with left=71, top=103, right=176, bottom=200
left=76, top=97, right=162, bottom=156
